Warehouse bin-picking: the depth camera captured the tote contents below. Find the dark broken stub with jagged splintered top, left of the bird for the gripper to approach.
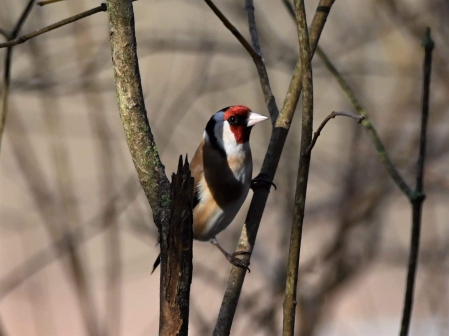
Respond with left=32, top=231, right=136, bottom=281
left=159, top=156, right=194, bottom=336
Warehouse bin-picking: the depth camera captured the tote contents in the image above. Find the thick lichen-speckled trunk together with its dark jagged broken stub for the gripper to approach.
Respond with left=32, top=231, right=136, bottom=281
left=108, top=0, right=193, bottom=336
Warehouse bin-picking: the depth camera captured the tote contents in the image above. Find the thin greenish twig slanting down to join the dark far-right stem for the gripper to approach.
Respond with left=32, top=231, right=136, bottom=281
left=316, top=47, right=413, bottom=198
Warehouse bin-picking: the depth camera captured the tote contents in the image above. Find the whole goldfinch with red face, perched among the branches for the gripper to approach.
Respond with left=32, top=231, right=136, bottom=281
left=153, top=105, right=270, bottom=271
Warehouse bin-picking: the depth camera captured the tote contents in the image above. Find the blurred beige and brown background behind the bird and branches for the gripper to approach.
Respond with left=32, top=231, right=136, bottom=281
left=0, top=0, right=449, bottom=336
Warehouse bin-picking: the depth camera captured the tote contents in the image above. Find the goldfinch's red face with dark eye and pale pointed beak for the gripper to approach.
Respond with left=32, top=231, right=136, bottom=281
left=224, top=105, right=268, bottom=144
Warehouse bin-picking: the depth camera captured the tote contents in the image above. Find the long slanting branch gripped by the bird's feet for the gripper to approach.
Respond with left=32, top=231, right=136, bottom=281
left=214, top=0, right=334, bottom=336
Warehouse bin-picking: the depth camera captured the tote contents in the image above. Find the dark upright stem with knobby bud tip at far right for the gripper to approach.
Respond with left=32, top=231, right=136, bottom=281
left=400, top=27, right=435, bottom=336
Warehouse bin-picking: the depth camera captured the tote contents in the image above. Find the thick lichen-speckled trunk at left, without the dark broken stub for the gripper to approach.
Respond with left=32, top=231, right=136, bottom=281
left=107, top=0, right=170, bottom=230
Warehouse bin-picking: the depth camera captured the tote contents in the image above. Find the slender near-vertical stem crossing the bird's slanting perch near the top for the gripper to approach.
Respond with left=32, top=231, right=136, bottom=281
left=283, top=0, right=313, bottom=336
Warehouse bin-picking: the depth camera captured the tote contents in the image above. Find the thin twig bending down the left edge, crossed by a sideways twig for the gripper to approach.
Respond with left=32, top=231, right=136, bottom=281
left=0, top=0, right=35, bottom=153
